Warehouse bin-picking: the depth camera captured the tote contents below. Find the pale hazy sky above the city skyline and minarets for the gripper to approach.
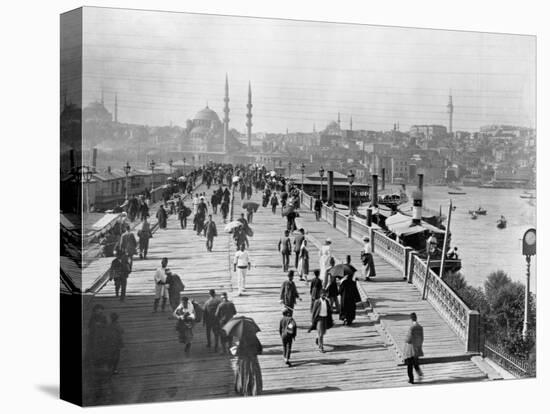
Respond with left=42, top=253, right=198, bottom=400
left=68, top=8, right=536, bottom=132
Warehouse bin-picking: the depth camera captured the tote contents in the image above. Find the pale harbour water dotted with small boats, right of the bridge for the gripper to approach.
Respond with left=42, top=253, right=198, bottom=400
left=420, top=186, right=536, bottom=292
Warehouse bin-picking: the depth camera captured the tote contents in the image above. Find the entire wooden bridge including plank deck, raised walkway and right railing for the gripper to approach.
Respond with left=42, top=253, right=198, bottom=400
left=70, top=176, right=499, bottom=405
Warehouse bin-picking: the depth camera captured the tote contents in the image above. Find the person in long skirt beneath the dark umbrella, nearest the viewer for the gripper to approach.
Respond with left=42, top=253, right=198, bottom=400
left=235, top=333, right=263, bottom=397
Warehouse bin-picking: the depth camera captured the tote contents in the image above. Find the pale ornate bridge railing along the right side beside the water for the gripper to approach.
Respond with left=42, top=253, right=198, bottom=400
left=302, top=189, right=481, bottom=352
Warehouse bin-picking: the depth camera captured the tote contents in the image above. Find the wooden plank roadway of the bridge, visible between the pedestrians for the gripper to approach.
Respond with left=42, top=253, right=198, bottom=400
left=81, top=189, right=486, bottom=405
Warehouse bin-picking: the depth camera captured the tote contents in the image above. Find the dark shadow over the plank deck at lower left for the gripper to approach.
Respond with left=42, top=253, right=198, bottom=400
left=82, top=292, right=236, bottom=406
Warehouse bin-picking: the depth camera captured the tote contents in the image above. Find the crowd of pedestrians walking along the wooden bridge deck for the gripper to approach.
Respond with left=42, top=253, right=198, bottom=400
left=88, top=160, right=421, bottom=395
